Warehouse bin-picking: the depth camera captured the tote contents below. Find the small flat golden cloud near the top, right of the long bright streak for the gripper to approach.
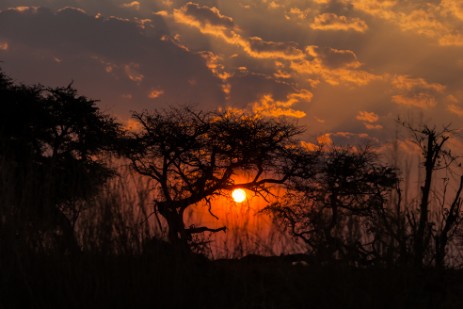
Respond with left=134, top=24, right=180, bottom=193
left=310, top=13, right=368, bottom=32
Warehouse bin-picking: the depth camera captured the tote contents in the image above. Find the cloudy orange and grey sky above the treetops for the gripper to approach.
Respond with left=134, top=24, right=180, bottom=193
left=0, top=0, right=463, bottom=144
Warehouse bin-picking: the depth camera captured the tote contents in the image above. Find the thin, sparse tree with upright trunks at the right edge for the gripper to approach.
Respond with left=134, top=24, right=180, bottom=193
left=404, top=123, right=463, bottom=268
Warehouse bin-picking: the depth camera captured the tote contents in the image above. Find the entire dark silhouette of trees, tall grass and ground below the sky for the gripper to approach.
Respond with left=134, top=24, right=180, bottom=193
left=0, top=70, right=463, bottom=308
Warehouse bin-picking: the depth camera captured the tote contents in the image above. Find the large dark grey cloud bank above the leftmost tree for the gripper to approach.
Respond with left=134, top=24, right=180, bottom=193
left=0, top=8, right=224, bottom=116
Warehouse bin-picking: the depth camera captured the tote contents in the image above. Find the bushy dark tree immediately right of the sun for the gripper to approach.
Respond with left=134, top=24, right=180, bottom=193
left=265, top=147, right=397, bottom=264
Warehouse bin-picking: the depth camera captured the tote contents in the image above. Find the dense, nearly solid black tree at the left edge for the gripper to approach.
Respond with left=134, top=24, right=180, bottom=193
left=0, top=69, right=121, bottom=250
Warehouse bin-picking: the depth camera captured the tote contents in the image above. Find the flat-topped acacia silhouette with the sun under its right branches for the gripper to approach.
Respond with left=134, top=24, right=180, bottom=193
left=128, top=108, right=308, bottom=249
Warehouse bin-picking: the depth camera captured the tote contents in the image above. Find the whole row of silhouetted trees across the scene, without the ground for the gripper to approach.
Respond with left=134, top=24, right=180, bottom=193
left=0, top=66, right=463, bottom=268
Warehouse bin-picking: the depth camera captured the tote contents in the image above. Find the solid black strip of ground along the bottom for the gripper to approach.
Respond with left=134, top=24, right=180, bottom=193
left=0, top=254, right=463, bottom=308
